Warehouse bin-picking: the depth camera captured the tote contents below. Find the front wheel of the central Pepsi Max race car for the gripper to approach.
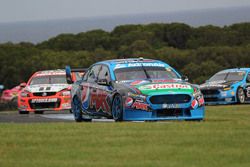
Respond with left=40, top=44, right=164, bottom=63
left=112, top=95, right=123, bottom=121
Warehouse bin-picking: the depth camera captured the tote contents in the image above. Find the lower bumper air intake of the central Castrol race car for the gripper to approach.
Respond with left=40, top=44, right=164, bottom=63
left=156, top=108, right=191, bottom=117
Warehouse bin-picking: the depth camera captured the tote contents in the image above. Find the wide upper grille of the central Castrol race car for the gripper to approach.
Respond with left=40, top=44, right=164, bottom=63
left=149, top=94, right=191, bottom=104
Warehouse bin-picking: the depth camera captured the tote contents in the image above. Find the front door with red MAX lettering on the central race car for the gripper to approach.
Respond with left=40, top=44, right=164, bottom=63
left=92, top=65, right=113, bottom=116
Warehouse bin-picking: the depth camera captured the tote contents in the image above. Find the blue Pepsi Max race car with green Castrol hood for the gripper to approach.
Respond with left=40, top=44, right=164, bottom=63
left=66, top=58, right=205, bottom=122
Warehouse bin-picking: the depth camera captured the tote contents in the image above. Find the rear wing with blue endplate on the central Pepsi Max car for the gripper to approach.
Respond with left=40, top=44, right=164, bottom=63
left=65, top=66, right=88, bottom=84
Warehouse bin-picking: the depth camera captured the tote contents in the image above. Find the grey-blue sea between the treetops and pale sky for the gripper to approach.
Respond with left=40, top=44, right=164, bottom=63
left=0, top=6, right=250, bottom=44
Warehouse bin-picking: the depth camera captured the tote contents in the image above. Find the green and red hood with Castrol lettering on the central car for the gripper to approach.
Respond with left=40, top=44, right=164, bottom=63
left=118, top=80, right=194, bottom=96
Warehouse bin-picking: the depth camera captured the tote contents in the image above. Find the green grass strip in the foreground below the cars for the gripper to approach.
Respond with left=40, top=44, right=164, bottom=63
left=0, top=105, right=250, bottom=167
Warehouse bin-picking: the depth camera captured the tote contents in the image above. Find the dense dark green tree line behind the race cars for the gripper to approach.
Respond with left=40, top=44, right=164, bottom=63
left=0, top=23, right=250, bottom=88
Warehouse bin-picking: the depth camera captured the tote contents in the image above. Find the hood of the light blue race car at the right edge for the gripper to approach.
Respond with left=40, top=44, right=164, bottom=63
left=200, top=80, right=238, bottom=90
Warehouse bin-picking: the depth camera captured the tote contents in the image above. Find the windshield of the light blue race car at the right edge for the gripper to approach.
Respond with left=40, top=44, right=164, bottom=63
left=209, top=71, right=246, bottom=81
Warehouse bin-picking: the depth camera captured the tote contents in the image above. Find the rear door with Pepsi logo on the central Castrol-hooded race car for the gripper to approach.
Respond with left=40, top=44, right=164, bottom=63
left=80, top=65, right=101, bottom=114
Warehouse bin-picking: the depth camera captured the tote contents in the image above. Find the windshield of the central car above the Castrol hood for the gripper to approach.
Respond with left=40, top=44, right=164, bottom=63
left=115, top=66, right=180, bottom=81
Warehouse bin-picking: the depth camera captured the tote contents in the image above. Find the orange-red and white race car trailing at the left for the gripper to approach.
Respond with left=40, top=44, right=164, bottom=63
left=18, top=70, right=82, bottom=114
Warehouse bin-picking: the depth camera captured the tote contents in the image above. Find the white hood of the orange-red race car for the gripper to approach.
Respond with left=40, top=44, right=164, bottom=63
left=25, top=84, right=69, bottom=93
